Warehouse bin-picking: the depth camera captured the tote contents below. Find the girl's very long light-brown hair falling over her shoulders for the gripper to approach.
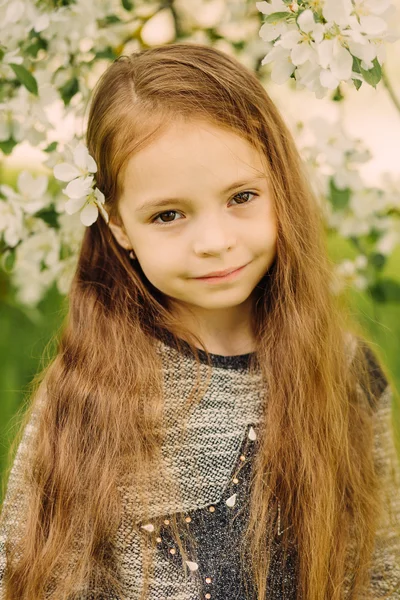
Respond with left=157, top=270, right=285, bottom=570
left=2, top=43, right=396, bottom=600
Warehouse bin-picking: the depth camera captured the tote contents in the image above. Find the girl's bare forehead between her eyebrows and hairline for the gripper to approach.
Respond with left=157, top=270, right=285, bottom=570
left=119, top=121, right=266, bottom=192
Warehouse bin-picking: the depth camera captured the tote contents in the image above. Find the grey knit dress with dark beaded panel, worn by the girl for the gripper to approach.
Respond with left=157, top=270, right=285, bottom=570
left=0, top=338, right=400, bottom=600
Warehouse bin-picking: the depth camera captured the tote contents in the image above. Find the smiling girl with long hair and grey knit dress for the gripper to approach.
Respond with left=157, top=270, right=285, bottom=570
left=1, top=44, right=400, bottom=600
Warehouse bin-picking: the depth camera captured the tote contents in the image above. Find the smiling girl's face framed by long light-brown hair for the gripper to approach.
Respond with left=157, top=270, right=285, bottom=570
left=110, top=121, right=276, bottom=330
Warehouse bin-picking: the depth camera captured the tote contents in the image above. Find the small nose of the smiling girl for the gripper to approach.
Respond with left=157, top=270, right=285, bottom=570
left=193, top=215, right=236, bottom=255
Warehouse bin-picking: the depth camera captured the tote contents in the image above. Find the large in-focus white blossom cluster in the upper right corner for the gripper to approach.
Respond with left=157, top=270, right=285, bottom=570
left=256, top=0, right=399, bottom=98
